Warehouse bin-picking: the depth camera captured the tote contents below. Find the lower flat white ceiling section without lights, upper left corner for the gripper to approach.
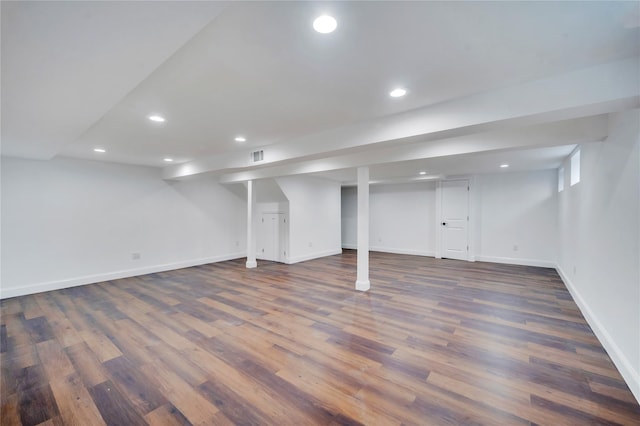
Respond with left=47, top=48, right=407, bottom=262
left=0, top=1, right=228, bottom=159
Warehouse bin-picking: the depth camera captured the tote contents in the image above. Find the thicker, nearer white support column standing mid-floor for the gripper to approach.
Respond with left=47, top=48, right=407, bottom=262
left=356, top=167, right=371, bottom=291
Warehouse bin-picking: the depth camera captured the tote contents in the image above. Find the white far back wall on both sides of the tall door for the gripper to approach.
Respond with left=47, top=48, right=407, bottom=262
left=342, top=175, right=557, bottom=267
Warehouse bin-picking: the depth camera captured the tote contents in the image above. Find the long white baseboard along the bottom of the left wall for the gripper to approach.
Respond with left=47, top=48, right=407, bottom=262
left=0, top=252, right=246, bottom=299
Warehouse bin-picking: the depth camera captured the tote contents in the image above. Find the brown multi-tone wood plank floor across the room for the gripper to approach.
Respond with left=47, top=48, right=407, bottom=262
left=0, top=251, right=640, bottom=425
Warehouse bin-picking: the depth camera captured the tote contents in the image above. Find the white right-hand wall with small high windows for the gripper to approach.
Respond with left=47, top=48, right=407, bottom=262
left=558, top=110, right=640, bottom=400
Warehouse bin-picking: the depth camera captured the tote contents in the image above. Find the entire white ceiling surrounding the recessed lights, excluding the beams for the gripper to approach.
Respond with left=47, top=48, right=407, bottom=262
left=1, top=1, right=640, bottom=181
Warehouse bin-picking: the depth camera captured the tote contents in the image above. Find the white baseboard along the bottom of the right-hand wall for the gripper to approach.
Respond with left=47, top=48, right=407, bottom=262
left=556, top=265, right=640, bottom=403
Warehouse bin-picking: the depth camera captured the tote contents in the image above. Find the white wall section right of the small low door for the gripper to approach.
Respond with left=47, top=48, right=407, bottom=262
left=276, top=176, right=342, bottom=263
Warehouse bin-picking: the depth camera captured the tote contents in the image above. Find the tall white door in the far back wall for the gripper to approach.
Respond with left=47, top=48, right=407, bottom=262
left=440, top=180, right=469, bottom=260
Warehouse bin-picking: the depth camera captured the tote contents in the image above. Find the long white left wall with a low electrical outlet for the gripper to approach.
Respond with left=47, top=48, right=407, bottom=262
left=1, top=157, right=246, bottom=297
